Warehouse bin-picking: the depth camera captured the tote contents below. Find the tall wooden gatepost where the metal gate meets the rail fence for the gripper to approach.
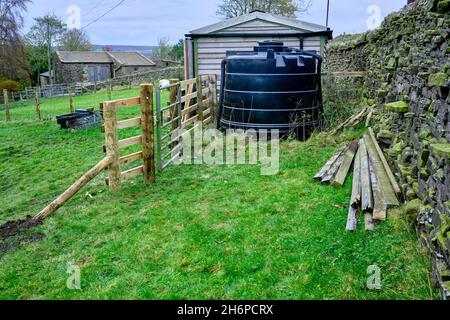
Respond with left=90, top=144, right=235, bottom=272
left=141, top=84, right=156, bottom=183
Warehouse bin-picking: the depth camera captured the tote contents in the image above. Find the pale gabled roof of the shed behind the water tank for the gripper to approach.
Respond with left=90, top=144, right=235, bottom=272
left=191, top=11, right=329, bottom=35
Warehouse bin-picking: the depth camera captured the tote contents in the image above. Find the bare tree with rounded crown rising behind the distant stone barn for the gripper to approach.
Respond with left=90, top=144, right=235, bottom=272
left=26, top=13, right=66, bottom=84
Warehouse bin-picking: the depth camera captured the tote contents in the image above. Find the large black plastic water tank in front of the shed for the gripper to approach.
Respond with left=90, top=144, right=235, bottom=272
left=217, top=41, right=323, bottom=135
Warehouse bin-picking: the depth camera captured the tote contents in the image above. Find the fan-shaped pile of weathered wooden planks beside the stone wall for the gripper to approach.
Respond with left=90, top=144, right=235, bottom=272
left=315, top=128, right=401, bottom=231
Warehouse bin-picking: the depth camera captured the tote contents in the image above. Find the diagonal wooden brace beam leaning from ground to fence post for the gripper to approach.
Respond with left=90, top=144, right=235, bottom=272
left=33, top=157, right=112, bottom=221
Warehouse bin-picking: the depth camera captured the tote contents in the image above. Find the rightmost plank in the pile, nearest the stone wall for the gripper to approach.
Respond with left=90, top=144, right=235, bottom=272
left=364, top=134, right=400, bottom=208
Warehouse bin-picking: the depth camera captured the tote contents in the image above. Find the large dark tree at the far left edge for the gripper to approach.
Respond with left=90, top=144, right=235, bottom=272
left=0, top=0, right=31, bottom=82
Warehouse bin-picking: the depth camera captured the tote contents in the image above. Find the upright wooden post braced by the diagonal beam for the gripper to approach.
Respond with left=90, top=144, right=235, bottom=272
left=103, top=101, right=121, bottom=192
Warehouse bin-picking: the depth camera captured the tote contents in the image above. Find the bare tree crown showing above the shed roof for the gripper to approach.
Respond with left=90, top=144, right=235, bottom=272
left=217, top=0, right=311, bottom=19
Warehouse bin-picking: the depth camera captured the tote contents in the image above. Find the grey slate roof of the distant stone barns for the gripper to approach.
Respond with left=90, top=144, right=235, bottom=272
left=57, top=51, right=155, bottom=67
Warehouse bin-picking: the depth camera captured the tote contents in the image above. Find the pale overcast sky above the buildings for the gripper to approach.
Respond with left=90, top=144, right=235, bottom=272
left=23, top=0, right=406, bottom=45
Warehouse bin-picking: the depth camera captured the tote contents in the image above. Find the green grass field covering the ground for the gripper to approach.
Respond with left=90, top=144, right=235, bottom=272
left=0, top=89, right=438, bottom=300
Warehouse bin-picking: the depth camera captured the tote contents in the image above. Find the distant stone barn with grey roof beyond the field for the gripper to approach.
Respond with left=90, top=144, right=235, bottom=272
left=55, top=51, right=156, bottom=83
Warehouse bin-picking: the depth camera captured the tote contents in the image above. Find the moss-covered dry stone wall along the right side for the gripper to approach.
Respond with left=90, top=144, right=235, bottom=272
left=327, top=0, right=450, bottom=299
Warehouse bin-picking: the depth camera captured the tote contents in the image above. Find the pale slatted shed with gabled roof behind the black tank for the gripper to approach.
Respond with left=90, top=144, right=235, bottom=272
left=185, top=11, right=332, bottom=80
